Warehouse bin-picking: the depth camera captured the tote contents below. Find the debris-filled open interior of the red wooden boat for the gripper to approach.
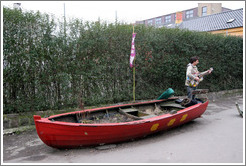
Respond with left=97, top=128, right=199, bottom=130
left=49, top=92, right=207, bottom=124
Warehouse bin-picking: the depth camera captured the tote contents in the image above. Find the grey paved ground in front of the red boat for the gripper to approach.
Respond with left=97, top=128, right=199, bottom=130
left=3, top=96, right=245, bottom=164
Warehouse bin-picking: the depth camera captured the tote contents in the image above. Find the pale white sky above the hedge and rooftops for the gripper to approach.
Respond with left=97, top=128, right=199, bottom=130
left=1, top=1, right=245, bottom=23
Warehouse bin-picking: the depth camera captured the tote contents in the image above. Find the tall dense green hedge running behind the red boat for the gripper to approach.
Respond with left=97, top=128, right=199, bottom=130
left=3, top=8, right=243, bottom=113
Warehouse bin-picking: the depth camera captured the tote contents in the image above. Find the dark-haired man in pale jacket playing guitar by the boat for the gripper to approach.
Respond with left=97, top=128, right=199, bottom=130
left=185, top=56, right=213, bottom=99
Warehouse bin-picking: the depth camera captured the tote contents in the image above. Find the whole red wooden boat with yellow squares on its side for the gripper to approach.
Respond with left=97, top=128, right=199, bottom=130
left=34, top=90, right=208, bottom=148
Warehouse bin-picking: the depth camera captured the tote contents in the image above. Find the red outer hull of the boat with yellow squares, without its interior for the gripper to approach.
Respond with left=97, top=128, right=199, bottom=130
left=34, top=100, right=208, bottom=148
